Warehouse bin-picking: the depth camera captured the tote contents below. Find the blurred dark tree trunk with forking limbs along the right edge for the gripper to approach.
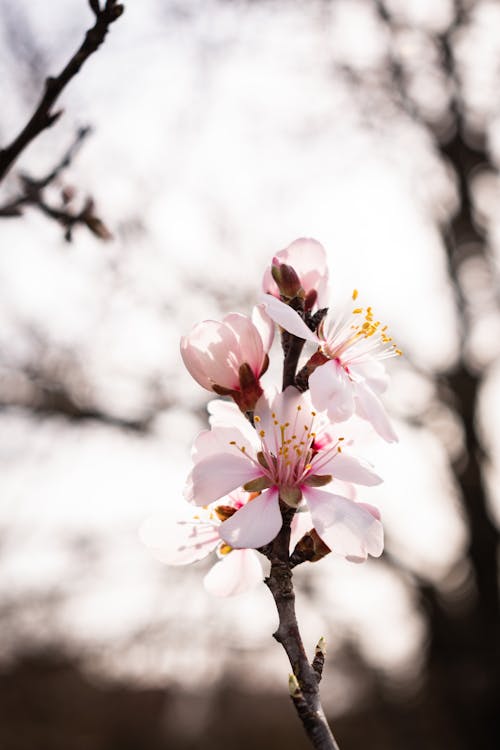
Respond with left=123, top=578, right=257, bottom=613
left=374, top=0, right=500, bottom=748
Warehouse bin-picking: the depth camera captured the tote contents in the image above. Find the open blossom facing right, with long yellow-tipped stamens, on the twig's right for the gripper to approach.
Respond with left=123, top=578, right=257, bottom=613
left=265, top=290, right=401, bottom=442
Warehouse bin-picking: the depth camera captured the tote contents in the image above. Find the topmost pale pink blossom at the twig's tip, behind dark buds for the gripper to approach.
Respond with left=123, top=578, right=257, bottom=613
left=262, top=238, right=328, bottom=307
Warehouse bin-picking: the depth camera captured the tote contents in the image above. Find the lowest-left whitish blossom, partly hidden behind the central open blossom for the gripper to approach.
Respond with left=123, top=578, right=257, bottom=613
left=139, top=492, right=262, bottom=596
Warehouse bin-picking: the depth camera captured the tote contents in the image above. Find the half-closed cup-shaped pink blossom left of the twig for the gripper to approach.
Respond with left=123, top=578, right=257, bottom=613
left=181, top=305, right=274, bottom=411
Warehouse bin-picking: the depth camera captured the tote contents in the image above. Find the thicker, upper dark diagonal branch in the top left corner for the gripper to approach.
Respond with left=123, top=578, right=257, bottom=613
left=0, top=0, right=124, bottom=184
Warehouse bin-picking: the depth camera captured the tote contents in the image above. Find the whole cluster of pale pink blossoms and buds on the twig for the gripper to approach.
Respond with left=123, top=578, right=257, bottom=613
left=141, top=239, right=401, bottom=596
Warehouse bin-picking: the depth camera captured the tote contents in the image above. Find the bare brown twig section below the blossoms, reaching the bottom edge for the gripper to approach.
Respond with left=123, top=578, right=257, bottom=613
left=261, top=507, right=339, bottom=750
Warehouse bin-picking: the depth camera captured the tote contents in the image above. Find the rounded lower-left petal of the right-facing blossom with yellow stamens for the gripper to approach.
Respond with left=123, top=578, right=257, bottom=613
left=309, top=360, right=354, bottom=422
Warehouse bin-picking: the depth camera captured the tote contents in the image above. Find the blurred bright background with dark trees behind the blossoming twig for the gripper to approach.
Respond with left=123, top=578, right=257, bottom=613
left=0, top=0, right=500, bottom=750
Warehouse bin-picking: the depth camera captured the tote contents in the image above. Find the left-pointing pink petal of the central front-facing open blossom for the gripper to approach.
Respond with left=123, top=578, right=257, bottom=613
left=184, top=453, right=262, bottom=508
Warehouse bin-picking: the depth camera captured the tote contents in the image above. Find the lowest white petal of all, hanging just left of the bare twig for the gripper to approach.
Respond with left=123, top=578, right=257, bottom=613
left=203, top=549, right=263, bottom=596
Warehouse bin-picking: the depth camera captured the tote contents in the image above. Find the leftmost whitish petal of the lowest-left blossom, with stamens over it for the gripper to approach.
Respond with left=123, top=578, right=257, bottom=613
left=139, top=510, right=220, bottom=565
